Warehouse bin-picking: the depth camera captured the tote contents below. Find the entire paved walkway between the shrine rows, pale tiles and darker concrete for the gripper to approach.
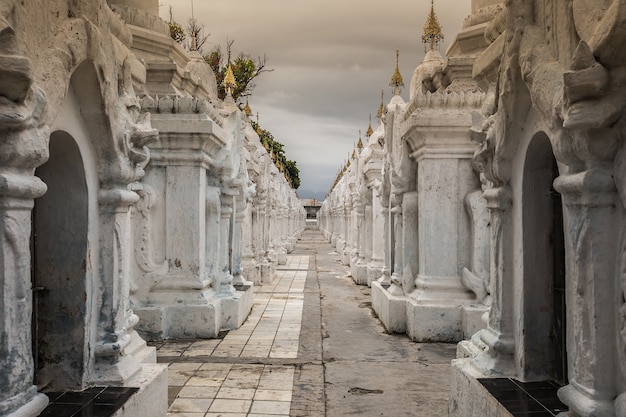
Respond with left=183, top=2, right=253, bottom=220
left=156, top=230, right=456, bottom=417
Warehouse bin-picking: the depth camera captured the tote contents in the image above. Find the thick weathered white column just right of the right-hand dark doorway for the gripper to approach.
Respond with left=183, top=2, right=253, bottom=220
left=555, top=160, right=619, bottom=417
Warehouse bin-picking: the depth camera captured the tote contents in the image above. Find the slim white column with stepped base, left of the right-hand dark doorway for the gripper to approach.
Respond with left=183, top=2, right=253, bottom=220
left=472, top=185, right=515, bottom=376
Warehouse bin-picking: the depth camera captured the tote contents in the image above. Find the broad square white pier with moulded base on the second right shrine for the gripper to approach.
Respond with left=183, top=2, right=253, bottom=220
left=405, top=92, right=479, bottom=342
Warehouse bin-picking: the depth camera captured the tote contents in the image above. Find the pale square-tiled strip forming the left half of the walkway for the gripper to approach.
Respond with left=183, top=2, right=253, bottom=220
left=157, top=255, right=309, bottom=417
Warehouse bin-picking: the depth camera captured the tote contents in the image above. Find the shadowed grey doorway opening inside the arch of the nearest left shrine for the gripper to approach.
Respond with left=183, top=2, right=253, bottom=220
left=32, top=131, right=88, bottom=390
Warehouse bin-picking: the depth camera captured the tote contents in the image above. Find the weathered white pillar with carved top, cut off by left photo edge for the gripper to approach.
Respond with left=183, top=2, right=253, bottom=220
left=0, top=33, right=49, bottom=415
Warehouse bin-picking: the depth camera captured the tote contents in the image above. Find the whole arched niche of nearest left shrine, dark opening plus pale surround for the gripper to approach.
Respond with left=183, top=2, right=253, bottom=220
left=32, top=61, right=106, bottom=391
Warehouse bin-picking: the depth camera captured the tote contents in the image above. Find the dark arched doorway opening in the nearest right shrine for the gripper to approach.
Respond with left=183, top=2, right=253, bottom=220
left=520, top=133, right=567, bottom=383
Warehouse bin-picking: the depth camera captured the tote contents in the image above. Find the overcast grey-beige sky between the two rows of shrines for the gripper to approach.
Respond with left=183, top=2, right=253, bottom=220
left=160, top=0, right=470, bottom=199
